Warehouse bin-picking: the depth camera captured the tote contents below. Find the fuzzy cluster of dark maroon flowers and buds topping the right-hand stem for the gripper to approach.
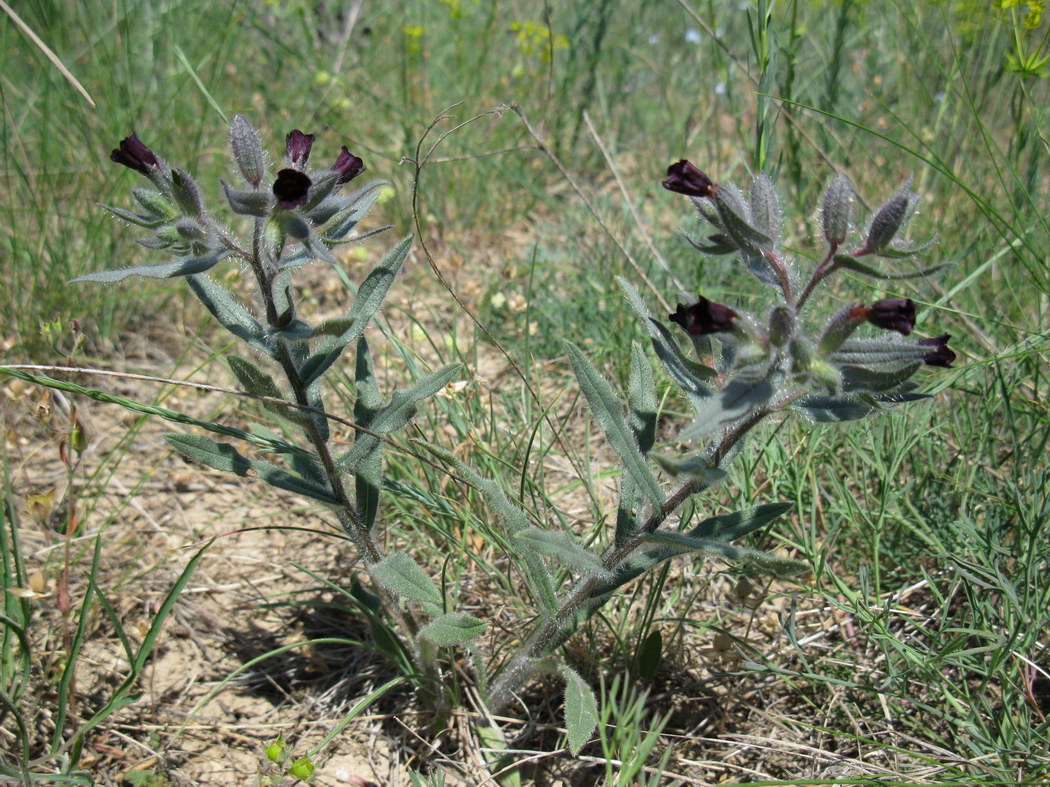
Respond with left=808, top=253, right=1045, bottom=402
left=663, top=159, right=956, bottom=432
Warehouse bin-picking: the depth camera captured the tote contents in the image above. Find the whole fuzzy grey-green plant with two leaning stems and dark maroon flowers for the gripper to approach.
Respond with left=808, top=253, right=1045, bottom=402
left=12, top=115, right=954, bottom=778
